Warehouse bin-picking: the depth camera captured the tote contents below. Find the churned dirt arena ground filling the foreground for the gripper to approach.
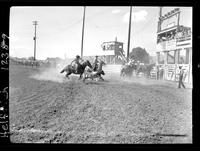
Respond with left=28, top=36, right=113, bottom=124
left=9, top=65, right=192, bottom=144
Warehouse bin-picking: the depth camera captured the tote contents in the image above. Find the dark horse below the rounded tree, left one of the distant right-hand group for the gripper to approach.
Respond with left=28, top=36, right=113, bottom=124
left=120, top=63, right=137, bottom=77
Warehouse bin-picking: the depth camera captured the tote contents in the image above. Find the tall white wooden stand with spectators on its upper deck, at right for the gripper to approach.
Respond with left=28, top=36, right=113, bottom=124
left=157, top=8, right=192, bottom=85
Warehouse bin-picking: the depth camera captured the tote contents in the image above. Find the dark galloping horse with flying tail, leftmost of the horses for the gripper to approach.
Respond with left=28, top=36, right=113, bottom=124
left=60, top=60, right=92, bottom=80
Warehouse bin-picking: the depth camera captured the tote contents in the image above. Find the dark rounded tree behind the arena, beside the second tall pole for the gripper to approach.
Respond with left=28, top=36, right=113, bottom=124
left=129, top=47, right=149, bottom=63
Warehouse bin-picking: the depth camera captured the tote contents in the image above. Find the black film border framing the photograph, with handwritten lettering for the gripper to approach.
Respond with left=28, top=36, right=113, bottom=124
left=0, top=0, right=200, bottom=148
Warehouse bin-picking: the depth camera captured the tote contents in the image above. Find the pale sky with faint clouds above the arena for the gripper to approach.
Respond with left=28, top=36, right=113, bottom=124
left=9, top=6, right=192, bottom=60
